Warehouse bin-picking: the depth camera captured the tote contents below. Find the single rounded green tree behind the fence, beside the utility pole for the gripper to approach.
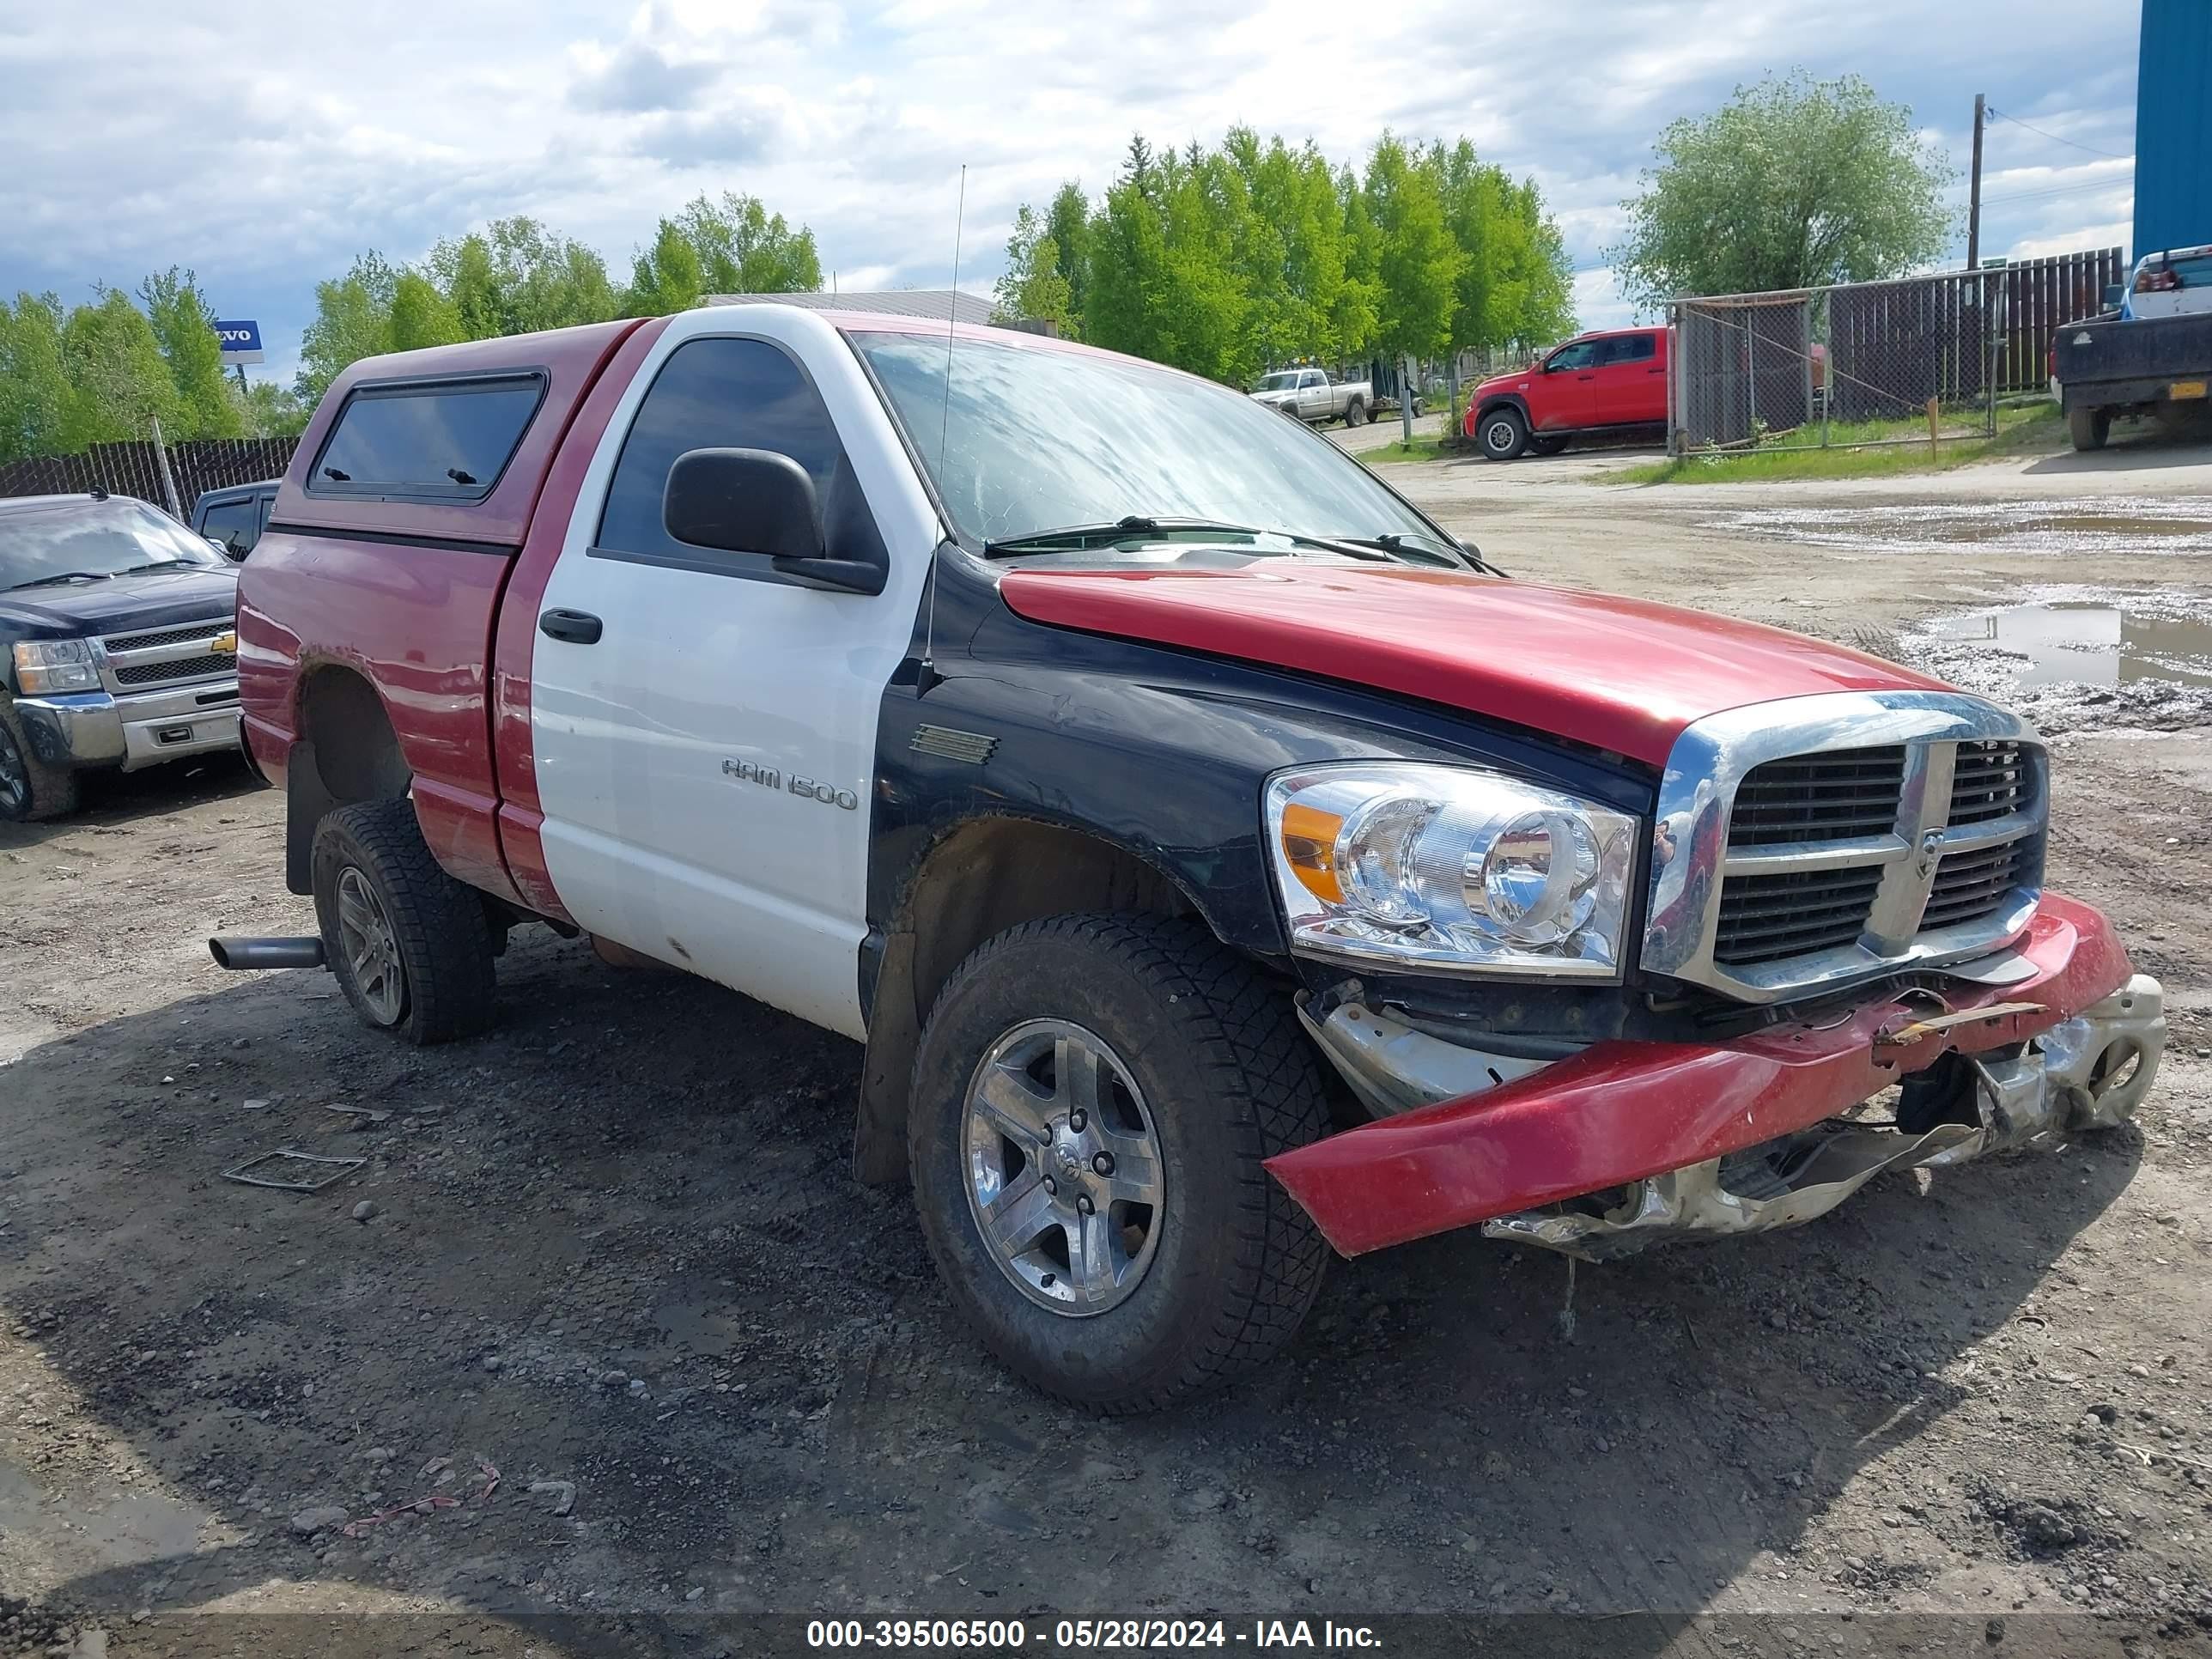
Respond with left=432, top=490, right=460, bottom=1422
left=1608, top=70, right=1958, bottom=303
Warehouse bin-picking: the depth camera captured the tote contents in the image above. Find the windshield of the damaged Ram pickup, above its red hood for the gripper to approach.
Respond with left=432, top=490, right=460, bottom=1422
left=852, top=334, right=1451, bottom=557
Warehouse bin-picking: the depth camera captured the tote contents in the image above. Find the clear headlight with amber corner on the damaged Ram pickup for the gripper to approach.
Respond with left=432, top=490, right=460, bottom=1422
left=1265, top=761, right=1637, bottom=980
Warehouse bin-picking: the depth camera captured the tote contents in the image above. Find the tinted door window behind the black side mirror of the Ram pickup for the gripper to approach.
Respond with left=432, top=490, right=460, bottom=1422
left=599, top=341, right=845, bottom=560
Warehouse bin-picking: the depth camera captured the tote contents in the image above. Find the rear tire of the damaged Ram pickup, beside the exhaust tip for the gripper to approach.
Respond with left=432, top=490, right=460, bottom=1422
left=314, top=801, right=493, bottom=1044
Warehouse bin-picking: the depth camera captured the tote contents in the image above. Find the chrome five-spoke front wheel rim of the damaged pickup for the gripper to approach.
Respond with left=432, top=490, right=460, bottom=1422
left=960, top=1020, right=1168, bottom=1318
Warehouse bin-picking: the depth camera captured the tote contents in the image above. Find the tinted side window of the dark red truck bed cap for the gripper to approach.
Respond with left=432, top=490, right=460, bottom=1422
left=307, top=376, right=544, bottom=500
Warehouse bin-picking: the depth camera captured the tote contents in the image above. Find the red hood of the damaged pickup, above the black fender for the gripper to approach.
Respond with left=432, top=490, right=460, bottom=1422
left=1000, top=560, right=1944, bottom=765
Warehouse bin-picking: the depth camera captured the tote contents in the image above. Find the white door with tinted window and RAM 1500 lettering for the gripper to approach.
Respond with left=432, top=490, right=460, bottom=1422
left=531, top=305, right=940, bottom=1037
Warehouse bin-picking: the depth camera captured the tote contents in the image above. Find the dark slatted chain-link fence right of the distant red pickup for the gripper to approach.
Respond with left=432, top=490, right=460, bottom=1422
left=1668, top=248, right=2119, bottom=456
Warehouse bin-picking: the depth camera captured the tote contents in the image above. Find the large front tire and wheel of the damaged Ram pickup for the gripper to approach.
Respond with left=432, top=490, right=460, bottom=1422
left=907, top=915, right=1328, bottom=1413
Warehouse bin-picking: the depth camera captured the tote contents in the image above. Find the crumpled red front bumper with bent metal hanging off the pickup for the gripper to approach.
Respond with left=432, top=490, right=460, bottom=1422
left=1267, top=894, right=2166, bottom=1259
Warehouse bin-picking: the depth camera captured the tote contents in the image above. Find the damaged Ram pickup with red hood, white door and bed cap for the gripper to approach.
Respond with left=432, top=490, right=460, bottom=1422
left=216, top=305, right=2166, bottom=1411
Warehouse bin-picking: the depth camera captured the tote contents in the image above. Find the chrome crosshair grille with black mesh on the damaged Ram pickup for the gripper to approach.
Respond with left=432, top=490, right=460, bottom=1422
left=1641, top=690, right=2046, bottom=1002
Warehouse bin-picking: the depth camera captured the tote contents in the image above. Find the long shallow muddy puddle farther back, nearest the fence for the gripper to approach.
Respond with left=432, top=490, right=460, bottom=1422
left=1708, top=495, right=2212, bottom=557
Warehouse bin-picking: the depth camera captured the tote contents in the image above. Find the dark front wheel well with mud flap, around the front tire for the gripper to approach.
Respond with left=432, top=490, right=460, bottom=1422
left=854, top=814, right=1221, bottom=1186
